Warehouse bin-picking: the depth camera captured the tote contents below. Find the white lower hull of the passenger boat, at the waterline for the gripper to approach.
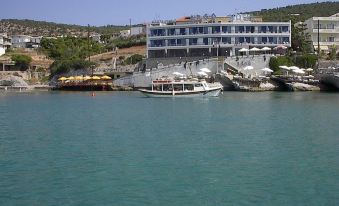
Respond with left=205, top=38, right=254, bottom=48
left=139, top=88, right=222, bottom=97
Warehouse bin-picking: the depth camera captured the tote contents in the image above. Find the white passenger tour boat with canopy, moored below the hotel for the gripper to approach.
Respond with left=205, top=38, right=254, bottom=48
left=139, top=79, right=223, bottom=97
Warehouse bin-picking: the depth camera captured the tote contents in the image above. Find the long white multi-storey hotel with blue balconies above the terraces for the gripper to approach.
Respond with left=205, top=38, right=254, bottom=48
left=146, top=15, right=291, bottom=58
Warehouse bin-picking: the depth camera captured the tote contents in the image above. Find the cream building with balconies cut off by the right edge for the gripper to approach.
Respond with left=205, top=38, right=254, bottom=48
left=305, top=13, right=339, bottom=53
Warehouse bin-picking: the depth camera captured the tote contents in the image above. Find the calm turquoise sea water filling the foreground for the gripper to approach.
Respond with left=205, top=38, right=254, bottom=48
left=0, top=92, right=339, bottom=206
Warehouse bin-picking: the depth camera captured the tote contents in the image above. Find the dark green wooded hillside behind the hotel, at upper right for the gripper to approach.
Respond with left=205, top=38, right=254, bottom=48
left=246, top=1, right=339, bottom=21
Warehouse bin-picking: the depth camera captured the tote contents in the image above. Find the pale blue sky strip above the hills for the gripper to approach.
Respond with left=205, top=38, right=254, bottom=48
left=0, top=0, right=334, bottom=26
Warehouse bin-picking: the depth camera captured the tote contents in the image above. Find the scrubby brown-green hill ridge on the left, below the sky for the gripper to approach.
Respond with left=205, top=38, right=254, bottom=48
left=0, top=19, right=127, bottom=37
